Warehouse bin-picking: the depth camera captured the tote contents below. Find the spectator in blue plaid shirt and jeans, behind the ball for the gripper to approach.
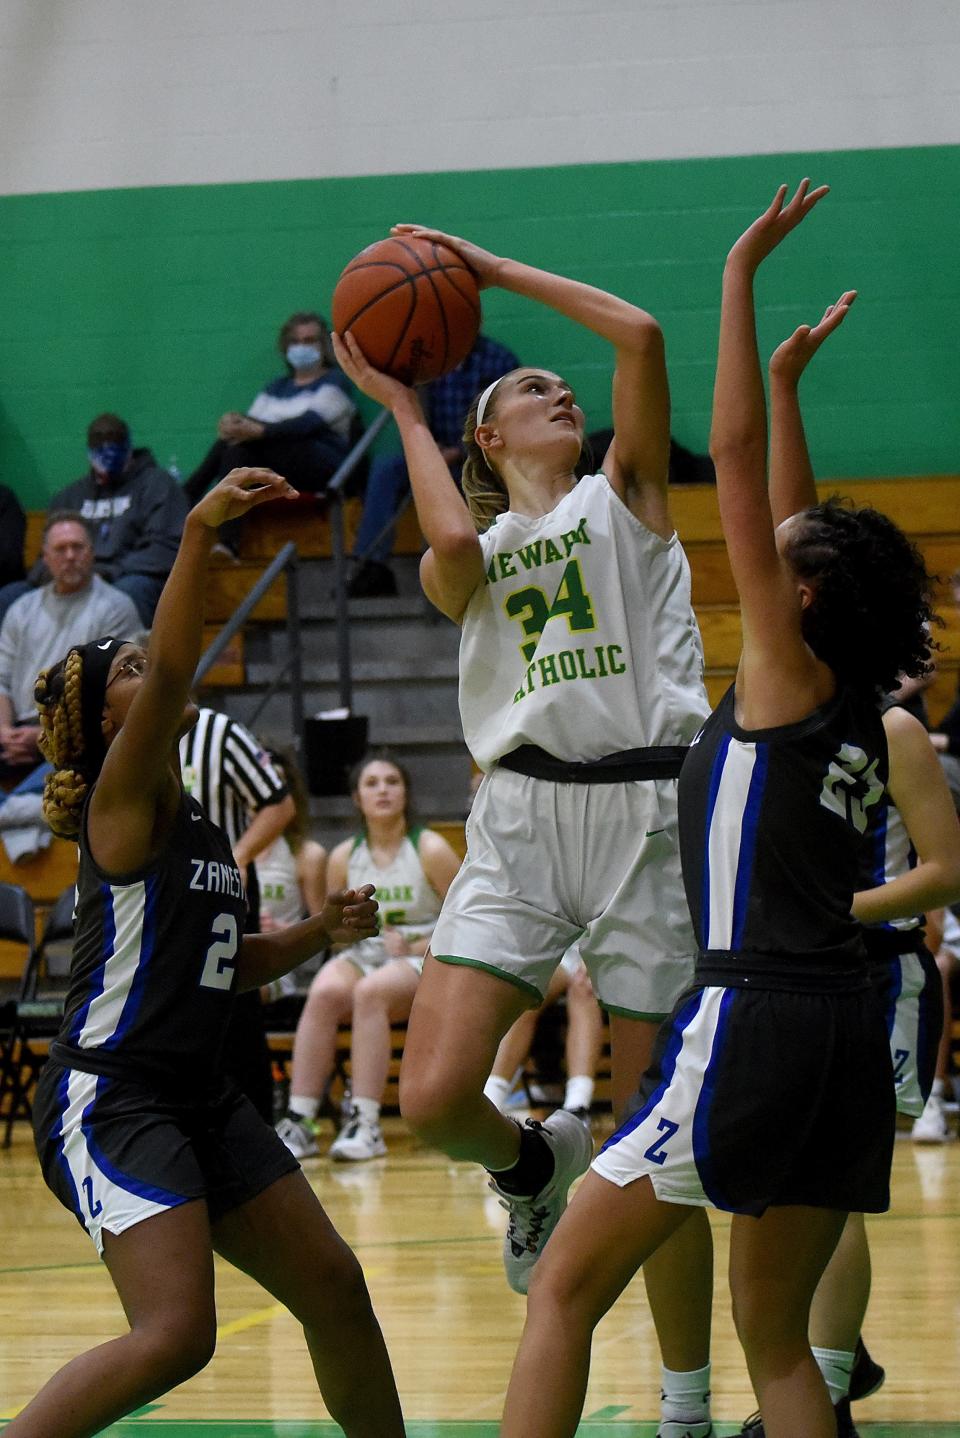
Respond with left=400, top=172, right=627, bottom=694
left=349, top=335, right=520, bottom=600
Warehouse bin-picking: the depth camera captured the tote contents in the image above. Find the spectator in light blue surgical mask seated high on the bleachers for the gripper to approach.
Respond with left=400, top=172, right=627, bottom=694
left=184, top=311, right=356, bottom=509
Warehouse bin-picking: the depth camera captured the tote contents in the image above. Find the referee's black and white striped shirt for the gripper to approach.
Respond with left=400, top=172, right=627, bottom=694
left=180, top=709, right=287, bottom=847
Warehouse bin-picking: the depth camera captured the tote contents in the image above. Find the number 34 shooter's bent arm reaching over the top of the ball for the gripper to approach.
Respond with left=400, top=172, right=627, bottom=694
left=394, top=224, right=673, bottom=536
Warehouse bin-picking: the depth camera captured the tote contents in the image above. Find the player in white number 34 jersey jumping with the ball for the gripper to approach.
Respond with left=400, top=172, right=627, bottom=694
left=335, top=226, right=711, bottom=1438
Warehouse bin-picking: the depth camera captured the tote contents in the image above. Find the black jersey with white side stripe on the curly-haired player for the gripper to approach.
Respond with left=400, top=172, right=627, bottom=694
left=680, top=686, right=887, bottom=966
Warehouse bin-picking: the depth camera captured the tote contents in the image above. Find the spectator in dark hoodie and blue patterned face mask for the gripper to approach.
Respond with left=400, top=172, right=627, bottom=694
left=50, top=414, right=187, bottom=628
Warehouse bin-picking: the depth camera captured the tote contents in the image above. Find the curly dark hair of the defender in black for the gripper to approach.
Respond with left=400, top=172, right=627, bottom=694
left=786, top=495, right=941, bottom=693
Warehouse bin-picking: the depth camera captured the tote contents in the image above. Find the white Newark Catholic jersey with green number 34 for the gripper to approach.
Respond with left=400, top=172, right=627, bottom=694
left=460, top=473, right=710, bottom=769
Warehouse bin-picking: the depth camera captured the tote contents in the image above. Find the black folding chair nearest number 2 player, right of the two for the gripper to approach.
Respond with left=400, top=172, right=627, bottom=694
left=3, top=884, right=75, bottom=1149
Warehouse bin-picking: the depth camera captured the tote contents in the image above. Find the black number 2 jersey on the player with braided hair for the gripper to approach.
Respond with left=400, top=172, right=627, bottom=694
left=52, top=795, right=246, bottom=1090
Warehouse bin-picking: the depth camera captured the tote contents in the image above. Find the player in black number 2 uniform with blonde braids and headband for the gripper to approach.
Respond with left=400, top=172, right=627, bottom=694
left=6, top=469, right=404, bottom=1438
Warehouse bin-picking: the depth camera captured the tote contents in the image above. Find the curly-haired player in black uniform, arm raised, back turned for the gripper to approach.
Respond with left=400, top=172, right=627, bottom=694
left=500, top=181, right=936, bottom=1438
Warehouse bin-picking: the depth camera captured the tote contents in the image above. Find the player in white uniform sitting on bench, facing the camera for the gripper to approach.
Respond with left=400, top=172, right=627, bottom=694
left=277, top=755, right=460, bottom=1162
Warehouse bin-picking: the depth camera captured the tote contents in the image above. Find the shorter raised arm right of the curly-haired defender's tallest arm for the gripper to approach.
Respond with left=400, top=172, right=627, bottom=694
left=770, top=289, right=857, bottom=525
